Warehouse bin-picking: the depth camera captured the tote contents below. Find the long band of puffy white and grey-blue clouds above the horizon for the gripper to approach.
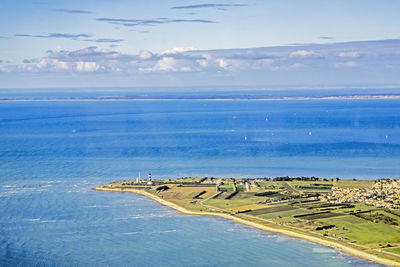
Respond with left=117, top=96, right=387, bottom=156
left=6, top=41, right=400, bottom=77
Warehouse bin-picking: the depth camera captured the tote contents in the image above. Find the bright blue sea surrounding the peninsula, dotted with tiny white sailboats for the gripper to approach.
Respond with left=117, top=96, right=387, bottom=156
left=0, top=91, right=400, bottom=266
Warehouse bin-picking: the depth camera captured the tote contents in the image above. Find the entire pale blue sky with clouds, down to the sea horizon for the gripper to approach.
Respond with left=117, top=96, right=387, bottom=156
left=0, top=0, right=400, bottom=88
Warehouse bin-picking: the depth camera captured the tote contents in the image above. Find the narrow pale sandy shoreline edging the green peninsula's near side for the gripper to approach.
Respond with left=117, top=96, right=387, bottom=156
left=95, top=187, right=400, bottom=266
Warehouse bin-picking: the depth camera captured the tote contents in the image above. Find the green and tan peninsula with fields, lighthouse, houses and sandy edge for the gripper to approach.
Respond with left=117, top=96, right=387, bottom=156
left=95, top=177, right=400, bottom=266
